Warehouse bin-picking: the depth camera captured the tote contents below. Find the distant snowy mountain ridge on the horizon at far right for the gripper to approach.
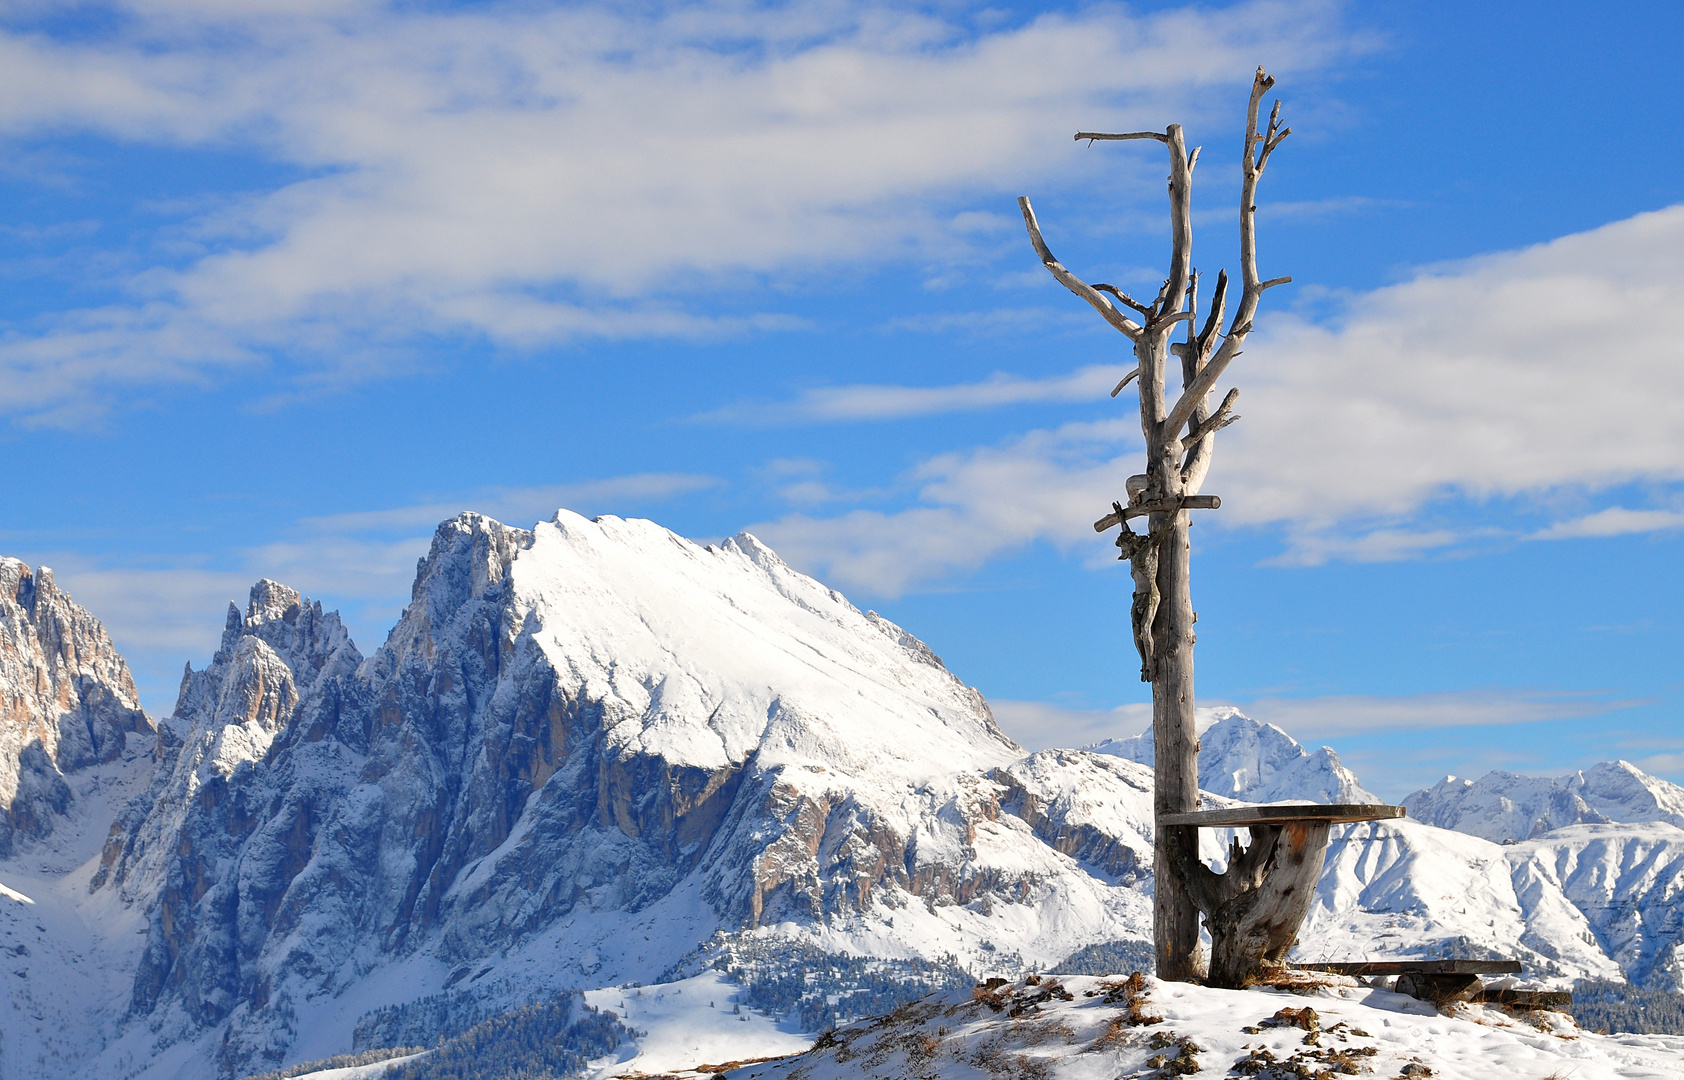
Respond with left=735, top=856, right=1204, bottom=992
left=1403, top=762, right=1684, bottom=842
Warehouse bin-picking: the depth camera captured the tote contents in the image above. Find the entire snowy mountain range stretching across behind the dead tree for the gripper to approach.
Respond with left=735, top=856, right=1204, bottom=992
left=0, top=511, right=1684, bottom=1080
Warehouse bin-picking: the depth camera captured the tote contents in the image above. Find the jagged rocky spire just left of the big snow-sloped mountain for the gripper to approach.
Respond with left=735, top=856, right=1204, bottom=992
left=93, top=581, right=365, bottom=1044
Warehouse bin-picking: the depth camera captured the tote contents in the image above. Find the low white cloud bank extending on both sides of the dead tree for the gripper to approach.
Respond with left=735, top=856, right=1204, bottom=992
left=756, top=206, right=1684, bottom=595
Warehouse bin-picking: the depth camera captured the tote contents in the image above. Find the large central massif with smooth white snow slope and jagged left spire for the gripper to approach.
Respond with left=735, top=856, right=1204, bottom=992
left=94, top=512, right=1150, bottom=1073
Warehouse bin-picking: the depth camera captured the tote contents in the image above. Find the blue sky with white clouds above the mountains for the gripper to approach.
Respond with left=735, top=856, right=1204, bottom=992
left=0, top=0, right=1684, bottom=797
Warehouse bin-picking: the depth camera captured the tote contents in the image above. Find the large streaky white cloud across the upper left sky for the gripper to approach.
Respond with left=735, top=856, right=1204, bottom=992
left=0, top=0, right=1352, bottom=414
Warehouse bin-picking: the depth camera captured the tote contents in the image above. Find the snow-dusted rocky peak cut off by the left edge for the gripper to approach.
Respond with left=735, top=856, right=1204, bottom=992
left=0, top=558, right=152, bottom=859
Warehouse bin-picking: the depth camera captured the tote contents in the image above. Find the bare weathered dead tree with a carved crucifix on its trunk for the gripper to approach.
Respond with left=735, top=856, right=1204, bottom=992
left=1017, top=67, right=1293, bottom=981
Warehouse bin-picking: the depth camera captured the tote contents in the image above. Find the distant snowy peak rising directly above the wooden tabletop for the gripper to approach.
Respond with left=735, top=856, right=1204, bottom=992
left=1088, top=706, right=1383, bottom=802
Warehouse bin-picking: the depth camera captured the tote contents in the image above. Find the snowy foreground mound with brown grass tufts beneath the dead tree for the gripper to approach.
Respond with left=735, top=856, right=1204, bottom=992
left=727, top=976, right=1684, bottom=1080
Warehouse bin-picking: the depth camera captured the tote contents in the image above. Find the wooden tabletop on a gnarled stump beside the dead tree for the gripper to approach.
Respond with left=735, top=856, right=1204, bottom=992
left=1157, top=802, right=1403, bottom=987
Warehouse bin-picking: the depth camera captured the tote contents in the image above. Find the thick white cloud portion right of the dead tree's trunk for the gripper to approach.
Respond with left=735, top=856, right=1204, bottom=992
left=1212, top=206, right=1684, bottom=527
